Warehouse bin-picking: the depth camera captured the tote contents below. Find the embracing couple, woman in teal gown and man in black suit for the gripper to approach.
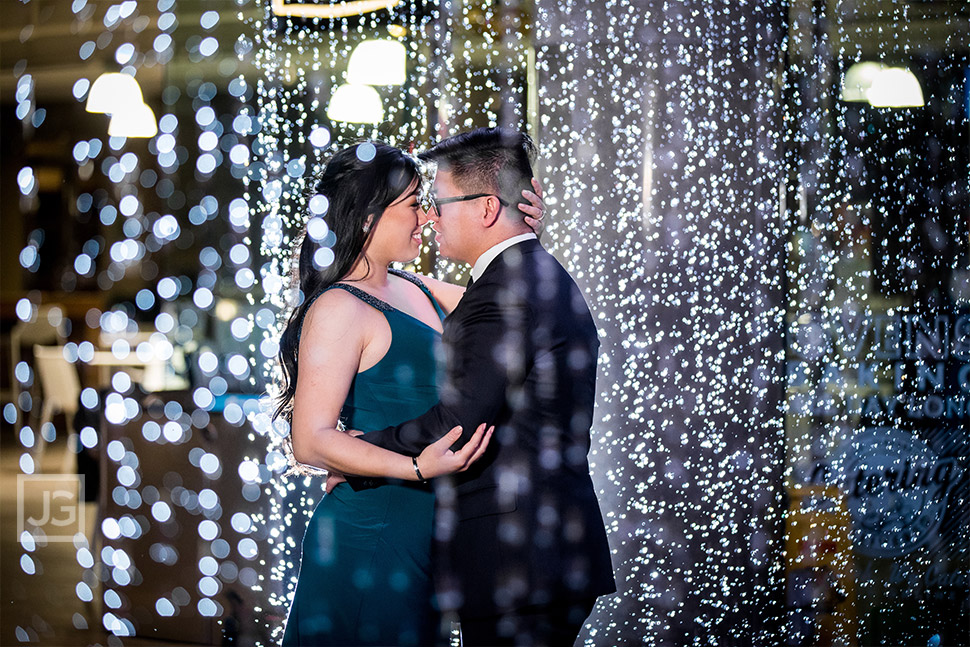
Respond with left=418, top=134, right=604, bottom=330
left=279, top=128, right=615, bottom=647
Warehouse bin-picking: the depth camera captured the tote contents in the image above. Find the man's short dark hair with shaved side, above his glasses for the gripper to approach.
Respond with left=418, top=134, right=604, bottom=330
left=420, top=128, right=537, bottom=219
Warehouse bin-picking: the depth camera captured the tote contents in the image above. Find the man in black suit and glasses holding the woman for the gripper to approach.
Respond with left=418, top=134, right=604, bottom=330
left=363, top=128, right=616, bottom=646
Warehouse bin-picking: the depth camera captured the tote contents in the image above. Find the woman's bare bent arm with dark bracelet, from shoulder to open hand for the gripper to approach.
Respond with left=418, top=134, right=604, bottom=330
left=290, top=290, right=491, bottom=481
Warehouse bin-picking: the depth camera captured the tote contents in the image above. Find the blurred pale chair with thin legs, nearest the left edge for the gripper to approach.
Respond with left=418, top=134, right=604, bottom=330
left=34, top=346, right=81, bottom=473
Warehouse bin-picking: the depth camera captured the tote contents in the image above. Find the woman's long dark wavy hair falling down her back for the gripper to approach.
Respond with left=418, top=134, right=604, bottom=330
left=274, top=142, right=421, bottom=421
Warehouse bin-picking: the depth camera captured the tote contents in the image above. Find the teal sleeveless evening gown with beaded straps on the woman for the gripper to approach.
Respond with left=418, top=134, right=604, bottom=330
left=282, top=270, right=444, bottom=647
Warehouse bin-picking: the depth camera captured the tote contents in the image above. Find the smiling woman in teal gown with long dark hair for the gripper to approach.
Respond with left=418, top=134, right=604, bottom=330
left=277, top=142, right=542, bottom=647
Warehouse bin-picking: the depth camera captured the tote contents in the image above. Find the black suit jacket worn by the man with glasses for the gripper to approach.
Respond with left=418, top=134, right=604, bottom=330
left=363, top=240, right=616, bottom=617
